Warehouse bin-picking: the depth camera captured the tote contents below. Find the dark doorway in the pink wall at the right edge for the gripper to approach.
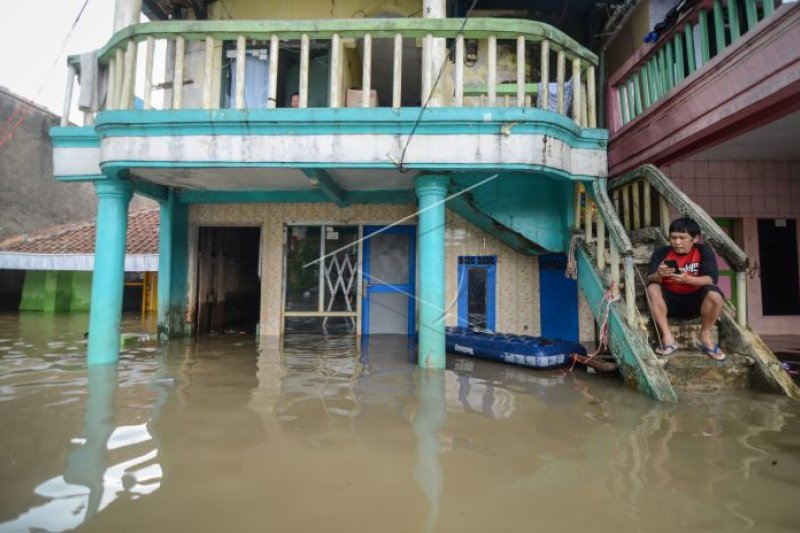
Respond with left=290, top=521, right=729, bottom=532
left=758, top=218, right=800, bottom=316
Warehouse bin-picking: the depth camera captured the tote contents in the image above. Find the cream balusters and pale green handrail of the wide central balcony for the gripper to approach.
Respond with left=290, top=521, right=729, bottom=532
left=63, top=18, right=597, bottom=128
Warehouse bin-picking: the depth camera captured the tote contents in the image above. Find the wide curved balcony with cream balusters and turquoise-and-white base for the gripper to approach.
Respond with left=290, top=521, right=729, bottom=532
left=52, top=18, right=606, bottom=190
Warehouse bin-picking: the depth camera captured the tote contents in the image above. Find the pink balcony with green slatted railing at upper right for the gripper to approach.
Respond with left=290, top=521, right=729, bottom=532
left=607, top=0, right=800, bottom=175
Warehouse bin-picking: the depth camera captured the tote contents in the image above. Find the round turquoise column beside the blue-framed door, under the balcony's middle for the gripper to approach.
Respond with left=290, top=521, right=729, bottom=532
left=414, top=175, right=449, bottom=368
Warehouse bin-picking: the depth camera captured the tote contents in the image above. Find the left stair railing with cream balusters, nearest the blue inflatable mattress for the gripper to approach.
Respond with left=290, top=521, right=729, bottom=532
left=574, top=178, right=638, bottom=326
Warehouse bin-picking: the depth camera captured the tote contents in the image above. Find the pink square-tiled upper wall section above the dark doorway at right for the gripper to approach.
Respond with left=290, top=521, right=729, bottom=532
left=662, top=161, right=800, bottom=218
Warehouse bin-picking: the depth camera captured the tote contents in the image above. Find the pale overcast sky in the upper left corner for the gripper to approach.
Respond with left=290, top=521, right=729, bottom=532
left=0, top=0, right=114, bottom=116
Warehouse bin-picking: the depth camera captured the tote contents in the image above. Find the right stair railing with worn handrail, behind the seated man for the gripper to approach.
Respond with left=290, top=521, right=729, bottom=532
left=608, top=165, right=750, bottom=327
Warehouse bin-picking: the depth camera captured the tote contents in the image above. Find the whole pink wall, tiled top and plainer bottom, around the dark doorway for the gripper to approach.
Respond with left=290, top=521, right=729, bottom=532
left=662, top=161, right=800, bottom=335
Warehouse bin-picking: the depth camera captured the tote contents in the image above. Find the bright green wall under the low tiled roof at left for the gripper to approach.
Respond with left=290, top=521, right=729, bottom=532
left=19, top=270, right=92, bottom=311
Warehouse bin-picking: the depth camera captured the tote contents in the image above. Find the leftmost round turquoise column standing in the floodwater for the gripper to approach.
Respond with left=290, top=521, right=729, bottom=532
left=88, top=180, right=132, bottom=365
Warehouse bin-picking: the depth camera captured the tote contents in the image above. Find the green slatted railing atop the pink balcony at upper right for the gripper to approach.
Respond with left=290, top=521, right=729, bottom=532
left=607, top=0, right=796, bottom=134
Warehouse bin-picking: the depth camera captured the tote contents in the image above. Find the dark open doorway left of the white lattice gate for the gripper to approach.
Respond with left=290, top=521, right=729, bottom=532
left=195, top=226, right=261, bottom=334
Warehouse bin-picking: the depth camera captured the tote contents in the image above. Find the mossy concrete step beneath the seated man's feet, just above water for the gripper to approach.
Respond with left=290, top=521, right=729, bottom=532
left=659, top=349, right=754, bottom=391
